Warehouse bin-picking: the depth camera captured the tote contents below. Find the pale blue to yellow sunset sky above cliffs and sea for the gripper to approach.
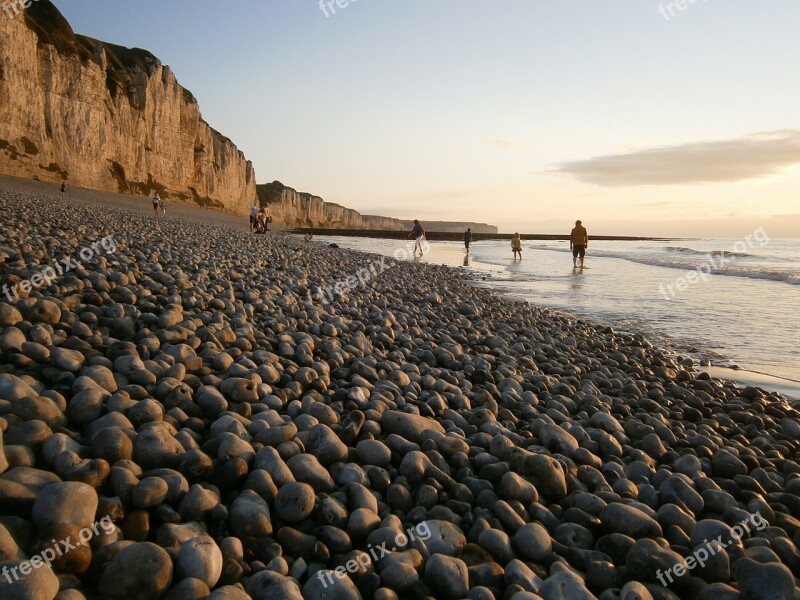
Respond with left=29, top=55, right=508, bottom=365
left=54, top=0, right=800, bottom=237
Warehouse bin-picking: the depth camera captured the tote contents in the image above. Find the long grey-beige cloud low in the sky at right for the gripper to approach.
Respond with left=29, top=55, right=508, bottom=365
left=555, top=129, right=800, bottom=187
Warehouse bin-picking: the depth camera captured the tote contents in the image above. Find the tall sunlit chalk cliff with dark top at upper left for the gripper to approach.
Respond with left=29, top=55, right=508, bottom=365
left=0, top=0, right=256, bottom=212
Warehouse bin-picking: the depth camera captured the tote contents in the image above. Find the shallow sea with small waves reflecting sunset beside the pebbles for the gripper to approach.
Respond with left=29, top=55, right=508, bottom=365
left=308, top=231, right=800, bottom=400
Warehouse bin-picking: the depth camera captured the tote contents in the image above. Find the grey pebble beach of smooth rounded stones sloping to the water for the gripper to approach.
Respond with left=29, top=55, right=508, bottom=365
left=0, top=184, right=800, bottom=600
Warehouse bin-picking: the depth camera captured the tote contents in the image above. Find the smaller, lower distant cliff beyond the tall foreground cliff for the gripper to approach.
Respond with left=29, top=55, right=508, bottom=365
left=257, top=181, right=403, bottom=231
